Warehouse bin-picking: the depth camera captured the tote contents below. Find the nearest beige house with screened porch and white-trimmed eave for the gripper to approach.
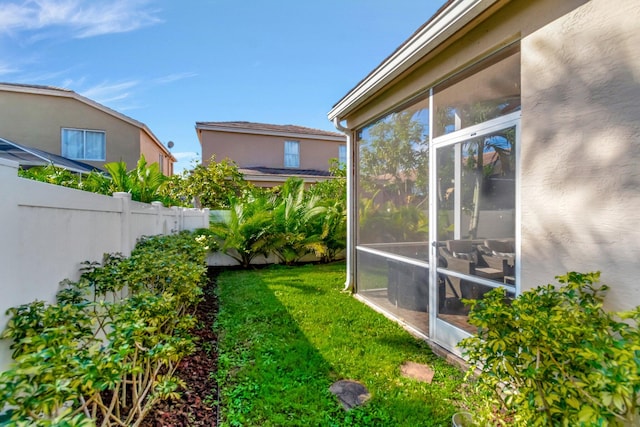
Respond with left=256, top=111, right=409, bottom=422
left=328, top=0, right=640, bottom=354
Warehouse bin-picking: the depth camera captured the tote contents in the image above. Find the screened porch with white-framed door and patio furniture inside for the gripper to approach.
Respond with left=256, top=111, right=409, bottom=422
left=354, top=43, right=520, bottom=352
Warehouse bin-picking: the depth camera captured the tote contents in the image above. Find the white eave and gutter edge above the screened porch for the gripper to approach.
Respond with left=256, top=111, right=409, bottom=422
left=327, top=0, right=504, bottom=122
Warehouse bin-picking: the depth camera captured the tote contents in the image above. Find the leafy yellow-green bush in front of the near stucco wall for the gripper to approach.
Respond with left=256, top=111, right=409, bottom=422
left=460, top=272, right=640, bottom=426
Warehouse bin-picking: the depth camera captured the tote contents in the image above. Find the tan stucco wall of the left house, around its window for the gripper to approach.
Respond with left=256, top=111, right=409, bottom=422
left=0, top=90, right=140, bottom=167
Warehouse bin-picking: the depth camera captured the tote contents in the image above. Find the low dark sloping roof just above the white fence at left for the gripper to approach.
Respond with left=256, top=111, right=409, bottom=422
left=0, top=138, right=104, bottom=173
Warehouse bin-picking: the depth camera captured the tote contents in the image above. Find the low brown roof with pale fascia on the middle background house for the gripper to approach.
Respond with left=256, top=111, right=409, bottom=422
left=196, top=121, right=345, bottom=141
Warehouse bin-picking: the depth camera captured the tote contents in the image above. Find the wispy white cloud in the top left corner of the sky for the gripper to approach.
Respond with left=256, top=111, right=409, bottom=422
left=0, top=0, right=162, bottom=38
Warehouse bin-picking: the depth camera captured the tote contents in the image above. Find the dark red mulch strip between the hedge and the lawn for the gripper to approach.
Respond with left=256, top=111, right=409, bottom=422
left=141, top=269, right=218, bottom=427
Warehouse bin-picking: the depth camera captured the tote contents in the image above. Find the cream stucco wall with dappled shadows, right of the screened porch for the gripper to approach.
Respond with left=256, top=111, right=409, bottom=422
left=520, top=0, right=640, bottom=308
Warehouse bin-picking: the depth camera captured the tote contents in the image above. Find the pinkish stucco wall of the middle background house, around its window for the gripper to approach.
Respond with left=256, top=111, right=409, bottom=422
left=201, top=130, right=346, bottom=170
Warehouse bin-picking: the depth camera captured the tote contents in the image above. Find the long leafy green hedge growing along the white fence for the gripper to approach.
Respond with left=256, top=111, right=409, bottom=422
left=0, top=232, right=207, bottom=426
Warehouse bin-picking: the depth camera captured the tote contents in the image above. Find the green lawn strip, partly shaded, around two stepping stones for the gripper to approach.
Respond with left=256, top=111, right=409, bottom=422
left=215, top=263, right=476, bottom=427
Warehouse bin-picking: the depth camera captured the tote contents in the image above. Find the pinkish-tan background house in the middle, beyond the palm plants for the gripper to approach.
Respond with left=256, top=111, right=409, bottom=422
left=196, top=122, right=346, bottom=187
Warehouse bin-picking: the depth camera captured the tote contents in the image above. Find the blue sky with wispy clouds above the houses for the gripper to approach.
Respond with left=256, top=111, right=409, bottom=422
left=0, top=0, right=444, bottom=172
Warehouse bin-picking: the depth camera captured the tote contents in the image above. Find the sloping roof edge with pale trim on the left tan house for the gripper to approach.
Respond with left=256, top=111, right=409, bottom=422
left=0, top=82, right=176, bottom=162
